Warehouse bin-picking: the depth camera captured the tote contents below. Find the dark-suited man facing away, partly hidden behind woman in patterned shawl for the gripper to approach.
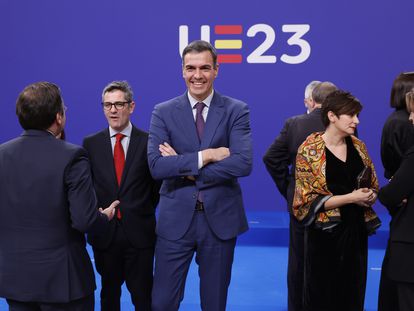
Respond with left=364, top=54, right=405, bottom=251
left=263, top=82, right=336, bottom=311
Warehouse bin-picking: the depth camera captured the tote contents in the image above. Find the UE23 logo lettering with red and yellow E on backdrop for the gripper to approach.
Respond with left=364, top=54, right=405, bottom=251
left=179, top=24, right=311, bottom=64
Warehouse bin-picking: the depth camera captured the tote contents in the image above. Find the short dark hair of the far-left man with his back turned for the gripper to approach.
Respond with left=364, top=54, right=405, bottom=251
left=16, top=82, right=64, bottom=130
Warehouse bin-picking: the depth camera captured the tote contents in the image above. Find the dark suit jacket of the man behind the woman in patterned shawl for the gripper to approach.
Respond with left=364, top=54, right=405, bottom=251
left=263, top=109, right=325, bottom=211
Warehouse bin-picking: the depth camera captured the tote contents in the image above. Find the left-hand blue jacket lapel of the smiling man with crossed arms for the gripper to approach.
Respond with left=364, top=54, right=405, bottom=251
left=174, top=93, right=200, bottom=146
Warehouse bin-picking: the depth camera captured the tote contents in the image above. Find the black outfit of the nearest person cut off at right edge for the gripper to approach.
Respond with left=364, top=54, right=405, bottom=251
left=378, top=146, right=414, bottom=311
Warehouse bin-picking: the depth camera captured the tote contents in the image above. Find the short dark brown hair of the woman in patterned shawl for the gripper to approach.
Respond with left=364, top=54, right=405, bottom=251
left=321, top=90, right=362, bottom=128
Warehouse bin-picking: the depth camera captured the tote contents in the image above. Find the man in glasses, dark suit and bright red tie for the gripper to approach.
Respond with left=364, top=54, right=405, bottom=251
left=83, top=81, right=159, bottom=311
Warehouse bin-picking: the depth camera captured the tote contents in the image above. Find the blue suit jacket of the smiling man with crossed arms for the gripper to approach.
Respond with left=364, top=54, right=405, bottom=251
left=148, top=92, right=252, bottom=240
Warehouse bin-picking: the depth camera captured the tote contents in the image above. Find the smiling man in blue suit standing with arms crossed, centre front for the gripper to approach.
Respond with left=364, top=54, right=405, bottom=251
left=148, top=41, right=252, bottom=311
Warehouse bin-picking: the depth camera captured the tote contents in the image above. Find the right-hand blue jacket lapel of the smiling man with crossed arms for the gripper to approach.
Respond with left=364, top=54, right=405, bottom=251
left=201, top=92, right=225, bottom=150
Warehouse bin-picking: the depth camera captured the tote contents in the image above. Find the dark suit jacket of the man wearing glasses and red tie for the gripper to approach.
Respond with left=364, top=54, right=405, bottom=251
left=83, top=126, right=159, bottom=249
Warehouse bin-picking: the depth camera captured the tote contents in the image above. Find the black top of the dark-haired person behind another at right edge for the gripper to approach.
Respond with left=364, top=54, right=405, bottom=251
left=381, top=109, right=414, bottom=179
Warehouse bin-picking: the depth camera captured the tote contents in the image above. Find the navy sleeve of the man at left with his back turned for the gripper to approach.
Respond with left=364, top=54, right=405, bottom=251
left=64, top=149, right=109, bottom=234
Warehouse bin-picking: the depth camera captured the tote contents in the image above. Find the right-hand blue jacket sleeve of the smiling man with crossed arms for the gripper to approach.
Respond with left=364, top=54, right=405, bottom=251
left=197, top=104, right=253, bottom=189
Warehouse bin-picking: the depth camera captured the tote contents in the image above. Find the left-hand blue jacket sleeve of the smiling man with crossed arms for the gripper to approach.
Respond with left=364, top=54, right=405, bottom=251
left=148, top=105, right=198, bottom=179
